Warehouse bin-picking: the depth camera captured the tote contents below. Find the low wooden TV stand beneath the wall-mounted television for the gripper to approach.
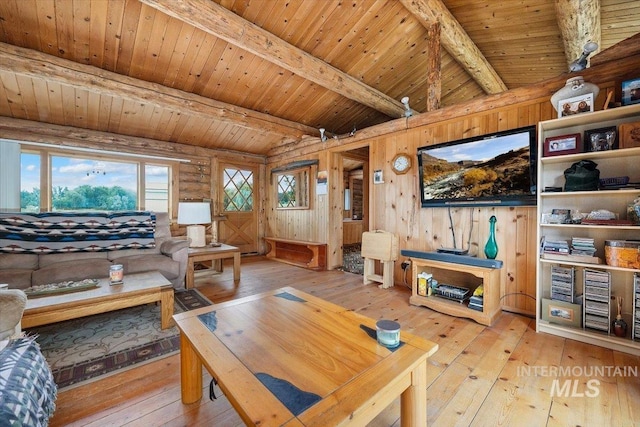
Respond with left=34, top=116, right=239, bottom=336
left=409, top=258, right=501, bottom=326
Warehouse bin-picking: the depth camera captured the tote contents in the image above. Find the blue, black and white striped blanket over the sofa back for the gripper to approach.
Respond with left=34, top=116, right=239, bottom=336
left=0, top=211, right=156, bottom=254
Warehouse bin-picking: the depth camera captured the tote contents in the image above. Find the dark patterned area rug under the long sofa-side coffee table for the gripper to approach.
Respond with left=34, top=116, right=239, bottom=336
left=26, top=289, right=211, bottom=389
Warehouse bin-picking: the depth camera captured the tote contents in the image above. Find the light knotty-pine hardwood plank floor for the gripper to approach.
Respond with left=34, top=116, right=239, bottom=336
left=50, top=257, right=640, bottom=427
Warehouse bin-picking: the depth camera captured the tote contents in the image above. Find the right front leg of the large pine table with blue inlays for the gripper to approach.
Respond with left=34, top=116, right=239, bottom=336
left=400, top=359, right=427, bottom=427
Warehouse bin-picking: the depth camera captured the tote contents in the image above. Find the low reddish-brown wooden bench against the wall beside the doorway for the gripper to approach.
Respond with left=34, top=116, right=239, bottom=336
left=264, top=237, right=327, bottom=270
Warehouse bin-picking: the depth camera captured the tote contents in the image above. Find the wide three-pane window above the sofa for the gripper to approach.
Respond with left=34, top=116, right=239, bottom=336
left=20, top=151, right=171, bottom=212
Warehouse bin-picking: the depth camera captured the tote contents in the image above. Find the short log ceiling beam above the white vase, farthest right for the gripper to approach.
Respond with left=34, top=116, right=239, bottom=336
left=555, top=0, right=601, bottom=69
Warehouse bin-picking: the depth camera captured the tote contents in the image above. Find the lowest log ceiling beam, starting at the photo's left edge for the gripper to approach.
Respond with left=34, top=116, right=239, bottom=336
left=0, top=43, right=312, bottom=142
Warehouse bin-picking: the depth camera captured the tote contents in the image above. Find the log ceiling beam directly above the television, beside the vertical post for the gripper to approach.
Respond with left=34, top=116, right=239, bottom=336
left=400, top=0, right=507, bottom=94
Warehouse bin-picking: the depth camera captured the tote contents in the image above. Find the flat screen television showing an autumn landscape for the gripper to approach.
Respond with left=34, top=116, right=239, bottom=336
left=418, top=126, right=537, bottom=207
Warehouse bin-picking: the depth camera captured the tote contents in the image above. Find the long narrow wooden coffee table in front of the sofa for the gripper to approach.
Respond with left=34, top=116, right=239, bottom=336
left=22, top=271, right=173, bottom=329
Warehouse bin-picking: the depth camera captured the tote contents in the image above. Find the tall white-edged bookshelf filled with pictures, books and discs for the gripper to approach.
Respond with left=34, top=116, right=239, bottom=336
left=536, top=105, right=640, bottom=355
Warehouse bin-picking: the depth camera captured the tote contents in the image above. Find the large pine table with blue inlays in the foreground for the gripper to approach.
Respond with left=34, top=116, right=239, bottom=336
left=174, top=287, right=438, bottom=427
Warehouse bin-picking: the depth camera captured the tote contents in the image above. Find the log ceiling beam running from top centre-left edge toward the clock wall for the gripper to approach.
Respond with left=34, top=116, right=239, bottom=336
left=140, top=0, right=404, bottom=118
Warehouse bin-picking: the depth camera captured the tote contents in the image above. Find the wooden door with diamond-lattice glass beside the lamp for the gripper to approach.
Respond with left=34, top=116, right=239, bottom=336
left=218, top=163, right=260, bottom=253
